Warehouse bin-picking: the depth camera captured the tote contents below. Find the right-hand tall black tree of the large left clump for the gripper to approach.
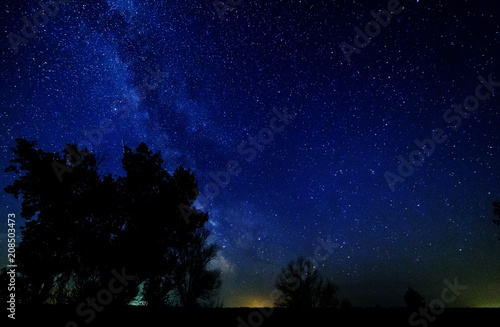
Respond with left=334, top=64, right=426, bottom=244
left=120, top=143, right=220, bottom=306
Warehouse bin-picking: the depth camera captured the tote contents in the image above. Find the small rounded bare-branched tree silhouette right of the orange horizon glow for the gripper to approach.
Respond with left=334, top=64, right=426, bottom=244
left=274, top=257, right=338, bottom=309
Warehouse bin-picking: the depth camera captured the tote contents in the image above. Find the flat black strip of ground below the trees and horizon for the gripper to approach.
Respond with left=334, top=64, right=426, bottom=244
left=10, top=306, right=500, bottom=327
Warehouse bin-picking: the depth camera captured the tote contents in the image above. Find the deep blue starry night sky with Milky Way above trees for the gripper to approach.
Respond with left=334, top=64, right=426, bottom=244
left=0, top=0, right=500, bottom=307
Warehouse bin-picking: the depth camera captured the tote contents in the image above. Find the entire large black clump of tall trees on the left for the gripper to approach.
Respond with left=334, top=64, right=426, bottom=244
left=5, top=139, right=220, bottom=305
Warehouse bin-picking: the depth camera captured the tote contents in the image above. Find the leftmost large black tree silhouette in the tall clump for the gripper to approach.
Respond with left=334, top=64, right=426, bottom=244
left=5, top=139, right=125, bottom=303
